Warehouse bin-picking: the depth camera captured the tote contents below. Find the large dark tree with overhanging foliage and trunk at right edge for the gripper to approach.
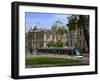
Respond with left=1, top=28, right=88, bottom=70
left=67, top=15, right=89, bottom=49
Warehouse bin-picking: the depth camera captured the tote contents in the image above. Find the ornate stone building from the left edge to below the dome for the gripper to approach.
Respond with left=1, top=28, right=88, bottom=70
left=25, top=26, right=67, bottom=53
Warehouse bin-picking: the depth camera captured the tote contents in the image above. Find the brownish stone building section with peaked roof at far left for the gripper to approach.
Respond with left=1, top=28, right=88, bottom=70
left=26, top=26, right=44, bottom=53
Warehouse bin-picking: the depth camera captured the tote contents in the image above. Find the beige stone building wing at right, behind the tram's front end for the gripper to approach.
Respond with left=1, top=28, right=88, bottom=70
left=68, top=28, right=88, bottom=52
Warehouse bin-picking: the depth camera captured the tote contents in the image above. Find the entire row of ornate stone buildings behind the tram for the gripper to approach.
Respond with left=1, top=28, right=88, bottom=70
left=25, top=18, right=89, bottom=54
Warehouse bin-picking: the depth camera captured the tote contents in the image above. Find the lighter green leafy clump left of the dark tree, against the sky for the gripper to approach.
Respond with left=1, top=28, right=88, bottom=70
left=67, top=15, right=79, bottom=30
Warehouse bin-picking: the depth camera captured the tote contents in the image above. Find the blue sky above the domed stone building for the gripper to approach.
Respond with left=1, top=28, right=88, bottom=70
left=25, top=12, right=69, bottom=32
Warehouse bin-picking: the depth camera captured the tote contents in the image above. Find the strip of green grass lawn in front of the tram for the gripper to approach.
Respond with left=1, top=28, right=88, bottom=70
left=25, top=56, right=80, bottom=65
